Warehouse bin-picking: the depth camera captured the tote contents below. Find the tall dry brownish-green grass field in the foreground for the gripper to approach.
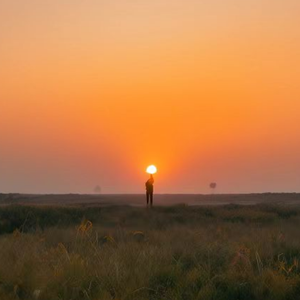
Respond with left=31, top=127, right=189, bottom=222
left=0, top=204, right=300, bottom=300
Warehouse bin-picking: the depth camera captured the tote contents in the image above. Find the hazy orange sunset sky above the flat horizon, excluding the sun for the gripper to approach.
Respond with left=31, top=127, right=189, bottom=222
left=0, top=0, right=300, bottom=193
